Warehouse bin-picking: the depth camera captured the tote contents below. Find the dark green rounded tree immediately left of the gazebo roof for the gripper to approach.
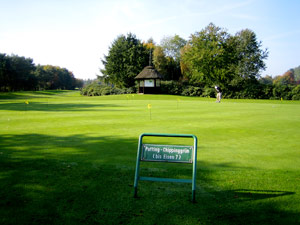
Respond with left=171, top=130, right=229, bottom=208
left=101, top=33, right=149, bottom=88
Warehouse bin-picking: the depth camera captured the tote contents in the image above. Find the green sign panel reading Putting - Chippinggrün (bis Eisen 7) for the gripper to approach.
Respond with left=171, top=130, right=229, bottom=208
left=141, top=144, right=193, bottom=163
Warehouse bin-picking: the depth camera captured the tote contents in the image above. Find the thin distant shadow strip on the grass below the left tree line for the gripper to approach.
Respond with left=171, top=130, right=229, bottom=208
left=0, top=102, right=124, bottom=112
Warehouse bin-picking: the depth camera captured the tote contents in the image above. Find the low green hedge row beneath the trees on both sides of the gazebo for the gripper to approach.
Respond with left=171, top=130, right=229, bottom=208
left=81, top=80, right=300, bottom=100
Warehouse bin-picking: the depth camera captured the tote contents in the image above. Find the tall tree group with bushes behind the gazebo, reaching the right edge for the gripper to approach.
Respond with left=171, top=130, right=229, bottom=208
left=94, top=23, right=300, bottom=99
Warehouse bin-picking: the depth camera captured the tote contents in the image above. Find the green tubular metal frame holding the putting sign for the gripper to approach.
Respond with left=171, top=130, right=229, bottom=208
left=134, top=133, right=197, bottom=203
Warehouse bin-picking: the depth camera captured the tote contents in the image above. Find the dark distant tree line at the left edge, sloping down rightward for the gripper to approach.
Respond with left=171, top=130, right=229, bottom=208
left=0, top=53, right=83, bottom=91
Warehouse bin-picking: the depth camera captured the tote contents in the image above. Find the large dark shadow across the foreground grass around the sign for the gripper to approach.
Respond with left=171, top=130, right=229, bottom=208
left=0, top=134, right=299, bottom=224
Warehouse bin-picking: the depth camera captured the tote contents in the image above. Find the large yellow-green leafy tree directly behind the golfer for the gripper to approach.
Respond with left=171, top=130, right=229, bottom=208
left=182, top=23, right=232, bottom=86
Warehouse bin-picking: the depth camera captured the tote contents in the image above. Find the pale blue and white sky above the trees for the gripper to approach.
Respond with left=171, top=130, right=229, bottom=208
left=0, top=0, right=300, bottom=79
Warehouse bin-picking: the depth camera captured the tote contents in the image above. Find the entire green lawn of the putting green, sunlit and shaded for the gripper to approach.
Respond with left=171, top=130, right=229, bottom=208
left=0, top=91, right=300, bottom=225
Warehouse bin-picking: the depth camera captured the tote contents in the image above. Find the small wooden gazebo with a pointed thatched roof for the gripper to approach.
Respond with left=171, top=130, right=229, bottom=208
left=135, top=66, right=163, bottom=94
